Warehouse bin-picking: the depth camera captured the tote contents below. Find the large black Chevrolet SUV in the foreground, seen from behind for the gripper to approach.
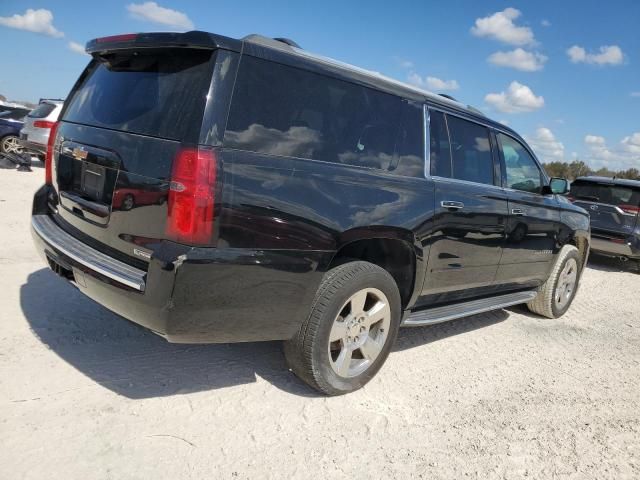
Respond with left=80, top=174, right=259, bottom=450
left=32, top=32, right=589, bottom=394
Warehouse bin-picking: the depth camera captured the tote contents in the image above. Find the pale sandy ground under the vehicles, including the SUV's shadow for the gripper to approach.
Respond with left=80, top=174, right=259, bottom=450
left=0, top=169, right=640, bottom=480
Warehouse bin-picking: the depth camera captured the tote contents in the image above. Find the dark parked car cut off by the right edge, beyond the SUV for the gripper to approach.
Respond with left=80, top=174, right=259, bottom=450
left=569, top=177, right=640, bottom=271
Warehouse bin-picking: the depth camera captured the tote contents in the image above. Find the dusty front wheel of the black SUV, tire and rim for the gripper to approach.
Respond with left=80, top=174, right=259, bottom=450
left=527, top=245, right=582, bottom=318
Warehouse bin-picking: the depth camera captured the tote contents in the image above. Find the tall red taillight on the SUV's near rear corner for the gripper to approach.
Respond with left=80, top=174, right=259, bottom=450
left=167, top=148, right=217, bottom=245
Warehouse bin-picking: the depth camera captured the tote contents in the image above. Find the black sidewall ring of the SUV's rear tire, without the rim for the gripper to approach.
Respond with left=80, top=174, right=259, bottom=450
left=312, top=267, right=402, bottom=394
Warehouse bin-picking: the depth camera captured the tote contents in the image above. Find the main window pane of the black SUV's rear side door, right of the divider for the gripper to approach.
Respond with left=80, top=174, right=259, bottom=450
left=447, top=115, right=493, bottom=185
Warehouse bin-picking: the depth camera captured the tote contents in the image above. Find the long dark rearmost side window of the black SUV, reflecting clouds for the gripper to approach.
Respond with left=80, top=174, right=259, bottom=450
left=225, top=56, right=422, bottom=172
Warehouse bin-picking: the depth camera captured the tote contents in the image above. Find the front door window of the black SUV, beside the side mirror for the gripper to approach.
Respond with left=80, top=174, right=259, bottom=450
left=497, top=133, right=542, bottom=193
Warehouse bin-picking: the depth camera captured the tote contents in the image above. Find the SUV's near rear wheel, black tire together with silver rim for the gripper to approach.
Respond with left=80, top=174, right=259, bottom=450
left=284, top=261, right=402, bottom=395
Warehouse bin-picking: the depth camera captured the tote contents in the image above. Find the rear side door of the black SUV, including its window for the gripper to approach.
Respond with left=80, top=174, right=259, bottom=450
left=423, top=110, right=508, bottom=301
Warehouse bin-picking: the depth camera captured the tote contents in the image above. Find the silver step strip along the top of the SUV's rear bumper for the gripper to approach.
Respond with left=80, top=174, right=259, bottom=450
left=31, top=215, right=146, bottom=292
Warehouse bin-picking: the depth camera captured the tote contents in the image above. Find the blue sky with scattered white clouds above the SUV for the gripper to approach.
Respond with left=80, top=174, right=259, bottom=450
left=0, top=0, right=640, bottom=169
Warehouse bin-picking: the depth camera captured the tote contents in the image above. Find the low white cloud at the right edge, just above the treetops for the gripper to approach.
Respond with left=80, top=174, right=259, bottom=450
left=584, top=132, right=640, bottom=170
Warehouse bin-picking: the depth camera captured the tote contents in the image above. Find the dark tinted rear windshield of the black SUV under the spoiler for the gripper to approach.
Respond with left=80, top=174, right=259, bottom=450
left=64, top=49, right=212, bottom=140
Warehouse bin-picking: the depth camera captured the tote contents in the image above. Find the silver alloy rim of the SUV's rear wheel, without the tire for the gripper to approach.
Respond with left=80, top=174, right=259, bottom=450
left=329, top=288, right=391, bottom=378
